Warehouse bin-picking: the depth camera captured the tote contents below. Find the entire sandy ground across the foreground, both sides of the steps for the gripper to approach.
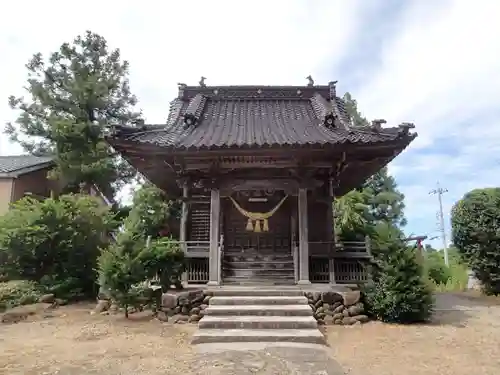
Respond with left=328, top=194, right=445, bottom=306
left=0, top=295, right=500, bottom=375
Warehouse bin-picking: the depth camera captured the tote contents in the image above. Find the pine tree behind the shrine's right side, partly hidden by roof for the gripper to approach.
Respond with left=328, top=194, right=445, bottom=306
left=344, top=92, right=406, bottom=226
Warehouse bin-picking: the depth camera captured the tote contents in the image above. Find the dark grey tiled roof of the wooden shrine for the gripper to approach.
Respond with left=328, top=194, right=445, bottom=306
left=108, top=83, right=413, bottom=150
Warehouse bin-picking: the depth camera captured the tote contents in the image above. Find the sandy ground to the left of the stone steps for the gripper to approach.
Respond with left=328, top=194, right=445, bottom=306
left=0, top=305, right=196, bottom=375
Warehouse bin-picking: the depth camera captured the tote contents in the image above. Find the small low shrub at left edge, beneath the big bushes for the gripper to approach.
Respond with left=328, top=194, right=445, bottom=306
left=0, top=280, right=42, bottom=311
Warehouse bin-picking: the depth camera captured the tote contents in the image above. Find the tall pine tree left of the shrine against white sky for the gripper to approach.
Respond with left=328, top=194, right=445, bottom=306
left=5, top=31, right=141, bottom=197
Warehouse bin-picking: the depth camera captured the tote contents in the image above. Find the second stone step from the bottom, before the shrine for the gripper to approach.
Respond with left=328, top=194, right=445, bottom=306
left=199, top=315, right=318, bottom=329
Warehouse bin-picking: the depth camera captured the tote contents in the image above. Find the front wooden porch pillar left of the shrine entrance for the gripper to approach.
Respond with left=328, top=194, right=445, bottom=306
left=207, top=188, right=220, bottom=285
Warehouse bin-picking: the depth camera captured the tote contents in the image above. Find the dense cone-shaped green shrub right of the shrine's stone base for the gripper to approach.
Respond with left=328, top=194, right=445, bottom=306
left=363, top=232, right=434, bottom=323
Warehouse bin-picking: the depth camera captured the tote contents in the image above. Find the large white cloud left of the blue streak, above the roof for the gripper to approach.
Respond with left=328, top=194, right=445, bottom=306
left=0, top=0, right=365, bottom=154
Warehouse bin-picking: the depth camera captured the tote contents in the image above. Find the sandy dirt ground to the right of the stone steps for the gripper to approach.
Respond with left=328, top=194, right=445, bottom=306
left=328, top=294, right=500, bottom=375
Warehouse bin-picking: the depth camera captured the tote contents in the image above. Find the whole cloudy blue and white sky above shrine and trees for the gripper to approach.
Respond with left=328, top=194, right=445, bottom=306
left=0, top=0, right=500, bottom=250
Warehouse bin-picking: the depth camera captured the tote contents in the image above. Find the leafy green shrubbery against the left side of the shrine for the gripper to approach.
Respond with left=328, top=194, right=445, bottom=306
left=98, top=184, right=185, bottom=314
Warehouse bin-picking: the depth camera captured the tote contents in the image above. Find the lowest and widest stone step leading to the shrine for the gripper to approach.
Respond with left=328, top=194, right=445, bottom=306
left=192, top=330, right=325, bottom=344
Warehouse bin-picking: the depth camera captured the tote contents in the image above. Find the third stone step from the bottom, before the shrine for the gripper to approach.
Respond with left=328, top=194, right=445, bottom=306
left=204, top=306, right=313, bottom=316
